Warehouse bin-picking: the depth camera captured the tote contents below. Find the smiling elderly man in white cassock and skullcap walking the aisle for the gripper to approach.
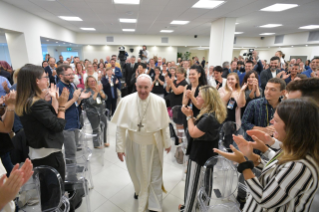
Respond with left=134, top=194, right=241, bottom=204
left=111, top=74, right=171, bottom=212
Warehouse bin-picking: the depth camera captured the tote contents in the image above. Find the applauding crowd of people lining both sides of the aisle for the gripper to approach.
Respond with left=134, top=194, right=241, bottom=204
left=0, top=46, right=319, bottom=212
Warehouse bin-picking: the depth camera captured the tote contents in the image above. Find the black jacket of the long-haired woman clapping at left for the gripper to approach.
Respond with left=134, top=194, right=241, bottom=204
left=20, top=99, right=66, bottom=149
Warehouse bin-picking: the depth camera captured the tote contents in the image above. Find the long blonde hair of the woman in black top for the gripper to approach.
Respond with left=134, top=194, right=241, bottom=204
left=197, top=85, right=227, bottom=123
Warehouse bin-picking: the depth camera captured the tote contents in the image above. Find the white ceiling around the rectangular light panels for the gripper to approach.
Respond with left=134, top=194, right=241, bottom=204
left=3, top=0, right=319, bottom=37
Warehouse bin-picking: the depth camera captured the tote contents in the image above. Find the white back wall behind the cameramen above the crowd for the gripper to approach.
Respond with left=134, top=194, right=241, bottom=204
left=81, top=45, right=177, bottom=61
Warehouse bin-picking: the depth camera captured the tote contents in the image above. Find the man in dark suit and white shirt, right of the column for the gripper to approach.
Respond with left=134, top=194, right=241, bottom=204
left=260, top=57, right=281, bottom=92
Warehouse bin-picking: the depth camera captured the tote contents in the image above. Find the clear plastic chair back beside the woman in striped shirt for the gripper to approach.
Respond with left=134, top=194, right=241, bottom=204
left=198, top=156, right=239, bottom=212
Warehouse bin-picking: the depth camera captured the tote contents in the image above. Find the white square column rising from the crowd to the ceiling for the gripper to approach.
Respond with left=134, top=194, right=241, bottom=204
left=208, top=18, right=236, bottom=66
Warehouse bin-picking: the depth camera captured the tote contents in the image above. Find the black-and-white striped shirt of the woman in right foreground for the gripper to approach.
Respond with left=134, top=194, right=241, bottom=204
left=243, top=151, right=318, bottom=212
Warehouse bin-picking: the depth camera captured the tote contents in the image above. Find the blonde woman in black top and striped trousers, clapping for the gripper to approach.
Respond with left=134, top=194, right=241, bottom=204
left=179, top=85, right=227, bottom=212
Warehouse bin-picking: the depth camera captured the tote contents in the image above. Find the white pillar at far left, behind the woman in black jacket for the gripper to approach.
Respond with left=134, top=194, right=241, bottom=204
left=5, top=31, right=42, bottom=70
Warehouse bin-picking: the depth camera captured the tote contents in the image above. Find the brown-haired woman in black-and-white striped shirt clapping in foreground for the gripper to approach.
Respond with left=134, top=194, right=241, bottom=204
left=214, top=99, right=319, bottom=212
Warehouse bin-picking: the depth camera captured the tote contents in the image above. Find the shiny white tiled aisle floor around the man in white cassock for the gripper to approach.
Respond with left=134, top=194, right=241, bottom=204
left=76, top=121, right=185, bottom=212
